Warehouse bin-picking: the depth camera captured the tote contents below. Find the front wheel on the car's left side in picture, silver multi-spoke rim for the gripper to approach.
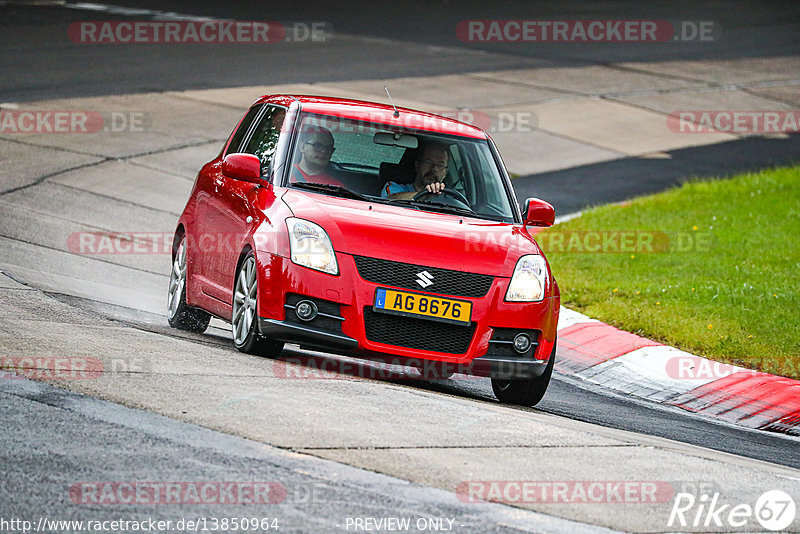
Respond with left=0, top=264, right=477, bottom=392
left=231, top=251, right=283, bottom=358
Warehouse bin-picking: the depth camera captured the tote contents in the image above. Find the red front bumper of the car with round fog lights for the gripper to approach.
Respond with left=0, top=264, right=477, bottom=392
left=257, top=252, right=559, bottom=378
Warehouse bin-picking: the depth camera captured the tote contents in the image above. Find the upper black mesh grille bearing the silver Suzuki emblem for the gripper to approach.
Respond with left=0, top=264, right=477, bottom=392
left=353, top=256, right=494, bottom=297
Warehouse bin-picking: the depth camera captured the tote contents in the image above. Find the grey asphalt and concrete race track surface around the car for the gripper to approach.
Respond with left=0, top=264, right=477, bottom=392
left=0, top=1, right=800, bottom=532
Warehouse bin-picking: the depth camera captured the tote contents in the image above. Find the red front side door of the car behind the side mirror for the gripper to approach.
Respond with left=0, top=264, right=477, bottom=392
left=202, top=105, right=286, bottom=306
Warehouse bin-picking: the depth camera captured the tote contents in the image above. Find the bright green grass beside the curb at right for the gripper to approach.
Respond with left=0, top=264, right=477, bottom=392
left=537, top=167, right=800, bottom=379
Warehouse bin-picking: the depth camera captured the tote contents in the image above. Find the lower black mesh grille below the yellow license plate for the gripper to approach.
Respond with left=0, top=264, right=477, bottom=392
left=364, top=306, right=475, bottom=354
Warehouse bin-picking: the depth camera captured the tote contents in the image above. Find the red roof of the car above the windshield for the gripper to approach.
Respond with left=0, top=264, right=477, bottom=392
left=255, top=94, right=487, bottom=139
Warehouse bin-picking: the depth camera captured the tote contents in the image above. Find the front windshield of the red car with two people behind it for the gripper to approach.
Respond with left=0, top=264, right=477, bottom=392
left=288, top=112, right=514, bottom=222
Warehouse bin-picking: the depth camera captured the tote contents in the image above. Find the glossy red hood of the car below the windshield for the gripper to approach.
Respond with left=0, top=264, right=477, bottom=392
left=283, top=190, right=541, bottom=277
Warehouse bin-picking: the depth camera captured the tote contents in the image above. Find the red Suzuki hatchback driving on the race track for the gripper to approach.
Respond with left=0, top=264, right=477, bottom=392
left=168, top=95, right=560, bottom=406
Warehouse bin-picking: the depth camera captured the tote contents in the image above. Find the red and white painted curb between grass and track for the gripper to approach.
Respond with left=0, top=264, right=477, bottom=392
left=556, top=307, right=800, bottom=436
